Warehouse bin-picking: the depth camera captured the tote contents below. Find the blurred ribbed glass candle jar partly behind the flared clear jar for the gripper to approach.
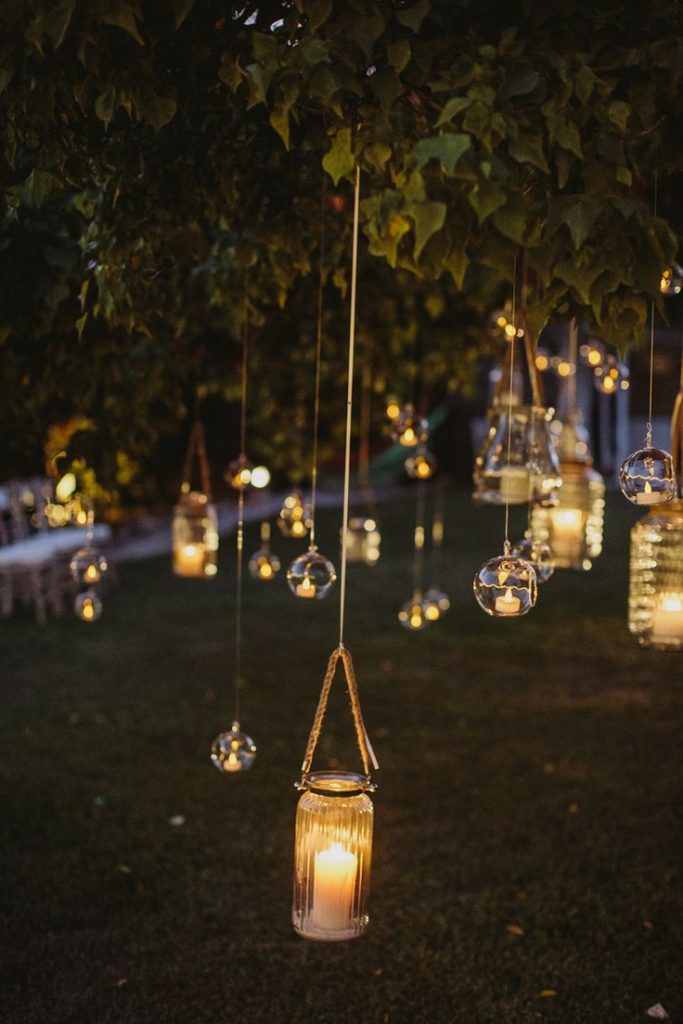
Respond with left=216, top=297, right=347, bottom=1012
left=530, top=462, right=605, bottom=571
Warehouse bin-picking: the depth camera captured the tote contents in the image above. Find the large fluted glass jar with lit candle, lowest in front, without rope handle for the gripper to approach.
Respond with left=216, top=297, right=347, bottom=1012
left=292, top=771, right=373, bottom=942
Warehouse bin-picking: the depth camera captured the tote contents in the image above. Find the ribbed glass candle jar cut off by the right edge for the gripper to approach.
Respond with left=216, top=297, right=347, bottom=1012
left=629, top=499, right=683, bottom=650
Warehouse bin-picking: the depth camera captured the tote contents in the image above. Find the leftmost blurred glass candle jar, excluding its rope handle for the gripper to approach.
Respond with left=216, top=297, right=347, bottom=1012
left=173, top=490, right=218, bottom=579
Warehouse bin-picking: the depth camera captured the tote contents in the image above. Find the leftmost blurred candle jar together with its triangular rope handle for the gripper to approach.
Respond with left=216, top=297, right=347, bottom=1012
left=172, top=420, right=218, bottom=580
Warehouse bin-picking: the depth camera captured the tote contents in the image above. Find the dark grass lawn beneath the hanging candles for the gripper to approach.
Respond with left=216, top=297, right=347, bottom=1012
left=0, top=493, right=683, bottom=1024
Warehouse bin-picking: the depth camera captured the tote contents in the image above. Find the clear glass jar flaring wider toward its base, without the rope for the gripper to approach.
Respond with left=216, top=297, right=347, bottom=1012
left=473, top=406, right=562, bottom=505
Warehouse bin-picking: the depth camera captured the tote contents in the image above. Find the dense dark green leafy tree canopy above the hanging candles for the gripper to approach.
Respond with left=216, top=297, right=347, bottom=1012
left=0, top=0, right=683, bottom=491
